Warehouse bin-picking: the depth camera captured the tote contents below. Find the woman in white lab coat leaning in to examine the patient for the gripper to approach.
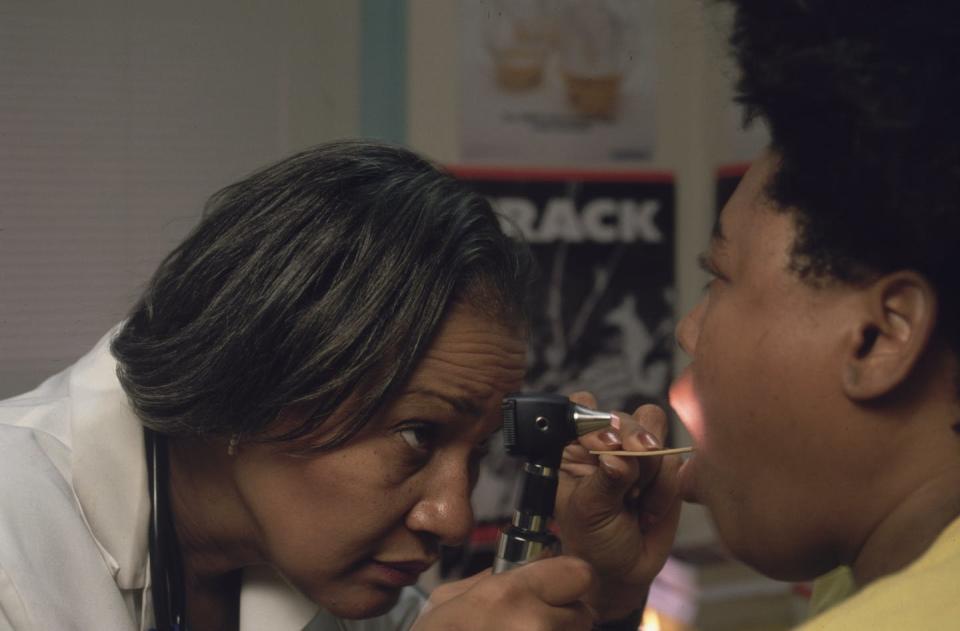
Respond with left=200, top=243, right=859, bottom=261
left=0, top=142, right=677, bottom=631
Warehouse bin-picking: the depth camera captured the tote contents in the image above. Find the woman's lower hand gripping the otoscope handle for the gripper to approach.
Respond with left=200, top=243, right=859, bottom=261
left=411, top=556, right=596, bottom=631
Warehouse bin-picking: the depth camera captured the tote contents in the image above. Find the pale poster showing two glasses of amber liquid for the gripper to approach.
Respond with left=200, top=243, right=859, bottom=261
left=460, top=0, right=656, bottom=165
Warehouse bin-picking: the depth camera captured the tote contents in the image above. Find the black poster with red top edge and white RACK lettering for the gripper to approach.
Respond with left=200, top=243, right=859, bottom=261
left=445, top=168, right=675, bottom=575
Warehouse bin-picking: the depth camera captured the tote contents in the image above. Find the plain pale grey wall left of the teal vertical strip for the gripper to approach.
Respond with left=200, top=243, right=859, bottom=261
left=0, top=0, right=360, bottom=397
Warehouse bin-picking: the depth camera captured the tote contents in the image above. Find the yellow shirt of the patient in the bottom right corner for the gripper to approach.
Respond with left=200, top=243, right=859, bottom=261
left=797, top=519, right=960, bottom=631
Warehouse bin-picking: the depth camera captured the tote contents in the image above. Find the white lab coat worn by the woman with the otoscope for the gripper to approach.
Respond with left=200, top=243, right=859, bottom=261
left=0, top=332, right=423, bottom=631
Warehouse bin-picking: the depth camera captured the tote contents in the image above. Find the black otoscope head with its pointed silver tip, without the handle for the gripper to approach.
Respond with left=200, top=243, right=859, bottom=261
left=502, top=393, right=613, bottom=468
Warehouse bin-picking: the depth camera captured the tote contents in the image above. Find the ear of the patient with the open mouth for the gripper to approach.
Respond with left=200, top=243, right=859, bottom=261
left=843, top=271, right=937, bottom=401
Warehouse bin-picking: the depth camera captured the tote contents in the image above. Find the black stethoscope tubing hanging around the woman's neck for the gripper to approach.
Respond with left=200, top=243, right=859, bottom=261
left=143, top=428, right=187, bottom=631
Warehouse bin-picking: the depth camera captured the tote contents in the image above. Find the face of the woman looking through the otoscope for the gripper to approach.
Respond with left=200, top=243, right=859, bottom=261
left=229, top=304, right=526, bottom=618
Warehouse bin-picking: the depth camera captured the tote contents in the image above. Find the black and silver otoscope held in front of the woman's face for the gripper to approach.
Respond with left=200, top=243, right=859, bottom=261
left=493, top=394, right=614, bottom=574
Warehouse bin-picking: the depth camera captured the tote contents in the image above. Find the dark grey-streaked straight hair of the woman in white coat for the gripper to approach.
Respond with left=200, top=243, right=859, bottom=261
left=111, top=141, right=531, bottom=447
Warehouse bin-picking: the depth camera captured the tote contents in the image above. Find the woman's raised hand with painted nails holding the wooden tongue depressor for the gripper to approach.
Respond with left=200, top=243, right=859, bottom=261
left=556, top=392, right=680, bottom=621
